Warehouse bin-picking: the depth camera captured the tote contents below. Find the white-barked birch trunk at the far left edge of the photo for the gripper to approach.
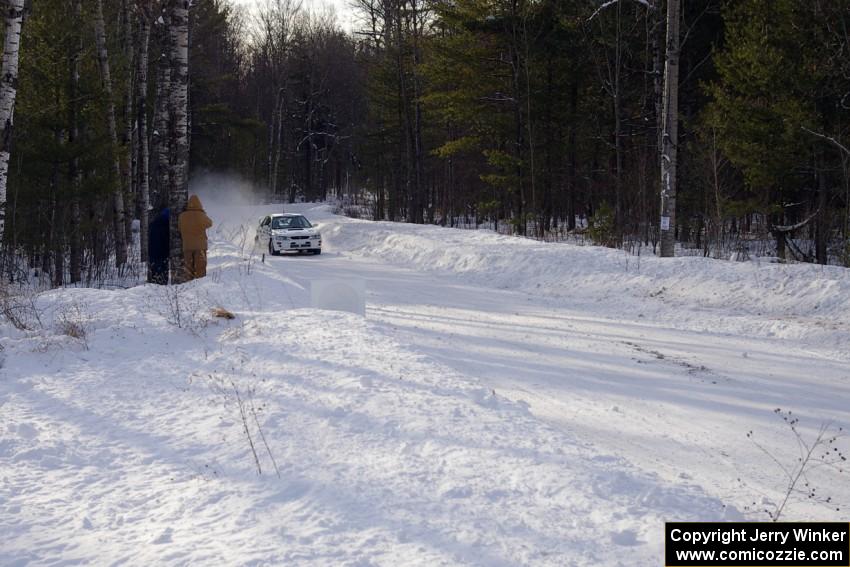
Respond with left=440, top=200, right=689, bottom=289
left=0, top=0, right=24, bottom=237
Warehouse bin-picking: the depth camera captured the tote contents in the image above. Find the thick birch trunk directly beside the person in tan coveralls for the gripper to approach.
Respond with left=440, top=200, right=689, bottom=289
left=169, top=0, right=189, bottom=283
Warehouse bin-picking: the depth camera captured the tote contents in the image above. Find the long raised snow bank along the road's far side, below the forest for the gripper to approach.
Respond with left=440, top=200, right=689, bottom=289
left=314, top=211, right=850, bottom=348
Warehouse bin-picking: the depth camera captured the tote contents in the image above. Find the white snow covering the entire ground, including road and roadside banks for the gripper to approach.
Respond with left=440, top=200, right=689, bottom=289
left=0, top=203, right=850, bottom=566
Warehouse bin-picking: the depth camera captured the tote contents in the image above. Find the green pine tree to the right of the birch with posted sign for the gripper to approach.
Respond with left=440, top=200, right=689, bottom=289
left=707, top=0, right=817, bottom=258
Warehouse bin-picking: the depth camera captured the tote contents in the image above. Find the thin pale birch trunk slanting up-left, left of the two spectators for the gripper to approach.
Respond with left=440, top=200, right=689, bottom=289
left=94, top=0, right=127, bottom=267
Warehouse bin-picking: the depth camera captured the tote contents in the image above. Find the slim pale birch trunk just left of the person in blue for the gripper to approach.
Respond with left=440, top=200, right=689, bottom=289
left=136, top=11, right=151, bottom=262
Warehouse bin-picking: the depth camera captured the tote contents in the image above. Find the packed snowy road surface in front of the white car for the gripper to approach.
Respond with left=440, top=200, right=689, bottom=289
left=264, top=210, right=850, bottom=520
